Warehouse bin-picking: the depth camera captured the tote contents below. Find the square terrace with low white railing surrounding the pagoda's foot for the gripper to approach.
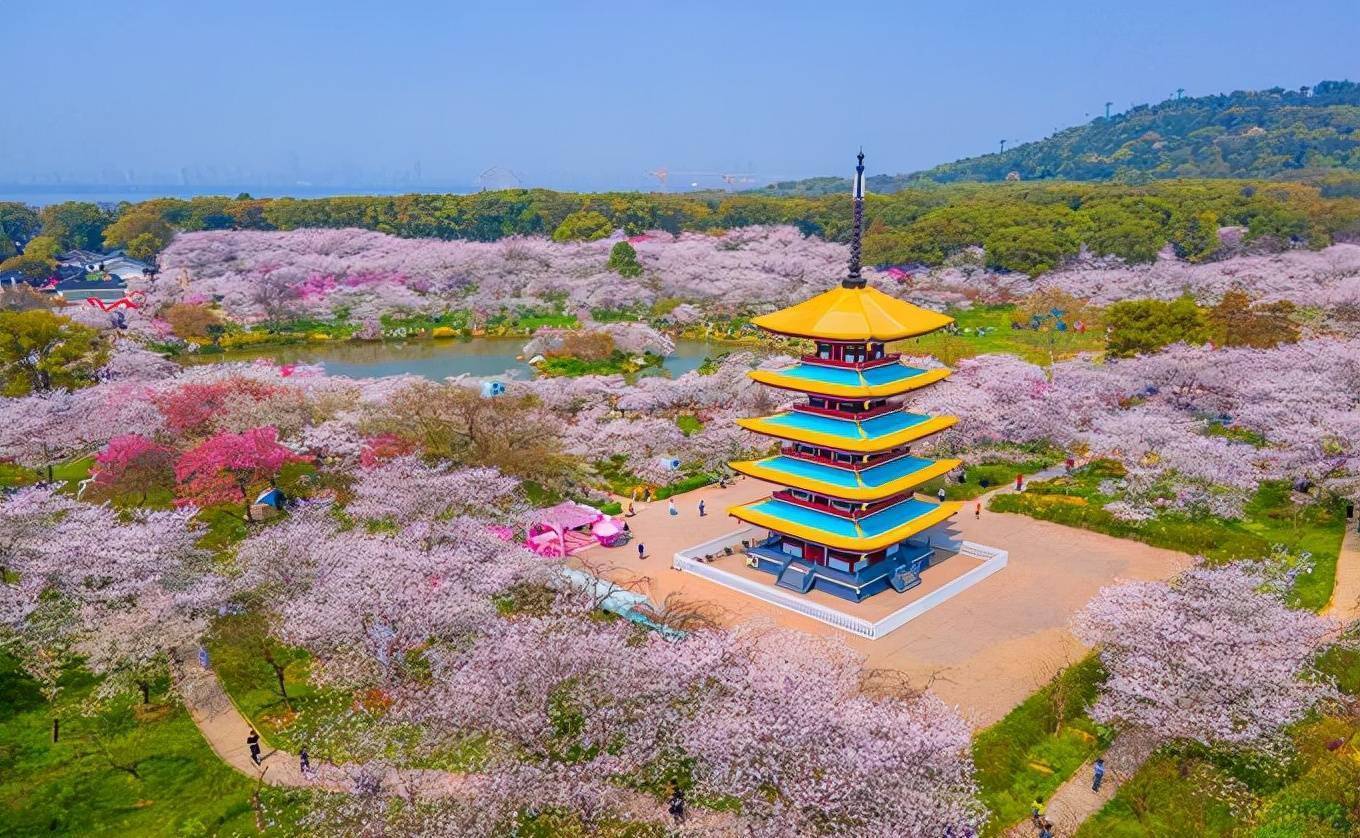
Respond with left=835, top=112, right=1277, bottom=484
left=672, top=526, right=1008, bottom=639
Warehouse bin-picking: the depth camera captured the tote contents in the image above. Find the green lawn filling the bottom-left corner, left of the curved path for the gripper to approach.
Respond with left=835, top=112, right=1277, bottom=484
left=0, top=654, right=308, bottom=837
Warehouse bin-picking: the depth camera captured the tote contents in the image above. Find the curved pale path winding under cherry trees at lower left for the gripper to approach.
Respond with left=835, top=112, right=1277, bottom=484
left=171, top=649, right=743, bottom=835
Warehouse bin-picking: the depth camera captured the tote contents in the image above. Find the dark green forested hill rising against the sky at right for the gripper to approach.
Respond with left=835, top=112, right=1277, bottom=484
left=762, top=82, right=1360, bottom=196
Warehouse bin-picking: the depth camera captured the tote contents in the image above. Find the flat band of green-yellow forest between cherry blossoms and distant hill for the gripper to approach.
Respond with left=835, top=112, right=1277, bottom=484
left=0, top=175, right=1360, bottom=276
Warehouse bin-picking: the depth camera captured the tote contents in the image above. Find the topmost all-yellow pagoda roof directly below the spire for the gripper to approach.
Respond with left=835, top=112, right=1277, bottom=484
left=751, top=286, right=953, bottom=340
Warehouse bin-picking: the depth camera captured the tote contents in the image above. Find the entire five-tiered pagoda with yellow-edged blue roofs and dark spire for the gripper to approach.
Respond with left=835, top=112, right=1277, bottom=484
left=728, top=151, right=962, bottom=601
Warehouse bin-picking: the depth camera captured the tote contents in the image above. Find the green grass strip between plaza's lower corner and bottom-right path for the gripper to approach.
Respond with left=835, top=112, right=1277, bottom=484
left=972, top=654, right=1108, bottom=835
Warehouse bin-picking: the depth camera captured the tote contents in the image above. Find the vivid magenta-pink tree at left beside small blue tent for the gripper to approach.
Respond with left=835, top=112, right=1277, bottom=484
left=174, top=427, right=309, bottom=521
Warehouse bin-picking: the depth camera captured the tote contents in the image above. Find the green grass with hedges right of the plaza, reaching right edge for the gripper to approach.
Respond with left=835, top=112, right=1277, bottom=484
left=990, top=463, right=1345, bottom=611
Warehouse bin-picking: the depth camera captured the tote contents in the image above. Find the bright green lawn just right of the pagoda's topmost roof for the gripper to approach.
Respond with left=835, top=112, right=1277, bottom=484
left=891, top=305, right=1104, bottom=366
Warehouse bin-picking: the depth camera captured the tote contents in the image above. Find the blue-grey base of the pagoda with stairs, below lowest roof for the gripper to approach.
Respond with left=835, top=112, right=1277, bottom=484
left=745, top=539, right=949, bottom=603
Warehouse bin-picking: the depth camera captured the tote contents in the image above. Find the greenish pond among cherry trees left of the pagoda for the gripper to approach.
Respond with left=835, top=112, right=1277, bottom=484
left=182, top=337, right=738, bottom=381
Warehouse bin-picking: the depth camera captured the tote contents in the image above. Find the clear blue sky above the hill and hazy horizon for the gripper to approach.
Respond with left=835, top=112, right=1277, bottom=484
left=0, top=0, right=1360, bottom=189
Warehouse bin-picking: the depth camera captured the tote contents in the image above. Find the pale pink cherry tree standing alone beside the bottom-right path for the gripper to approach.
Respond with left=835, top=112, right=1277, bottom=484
left=1073, top=565, right=1338, bottom=745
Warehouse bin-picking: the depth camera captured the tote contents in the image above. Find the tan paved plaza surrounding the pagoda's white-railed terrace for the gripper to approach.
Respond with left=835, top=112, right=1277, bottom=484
left=581, top=467, right=1191, bottom=726
